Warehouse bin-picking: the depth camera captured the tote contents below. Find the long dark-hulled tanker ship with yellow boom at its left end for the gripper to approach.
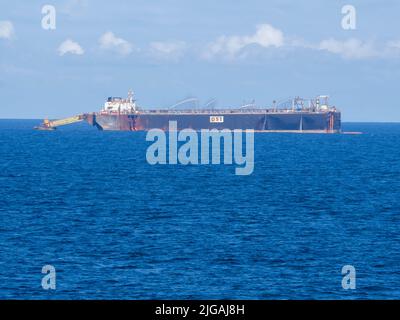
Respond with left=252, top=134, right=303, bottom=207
left=36, top=90, right=341, bottom=133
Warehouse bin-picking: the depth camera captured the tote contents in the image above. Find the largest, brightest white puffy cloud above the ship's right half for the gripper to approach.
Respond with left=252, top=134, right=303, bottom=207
left=204, top=24, right=284, bottom=59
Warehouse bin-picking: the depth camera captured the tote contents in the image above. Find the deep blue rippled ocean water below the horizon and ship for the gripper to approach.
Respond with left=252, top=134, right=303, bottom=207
left=0, top=120, right=400, bottom=299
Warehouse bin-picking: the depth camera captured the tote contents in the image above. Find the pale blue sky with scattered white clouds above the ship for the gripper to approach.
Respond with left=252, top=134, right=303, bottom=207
left=0, top=0, right=400, bottom=121
